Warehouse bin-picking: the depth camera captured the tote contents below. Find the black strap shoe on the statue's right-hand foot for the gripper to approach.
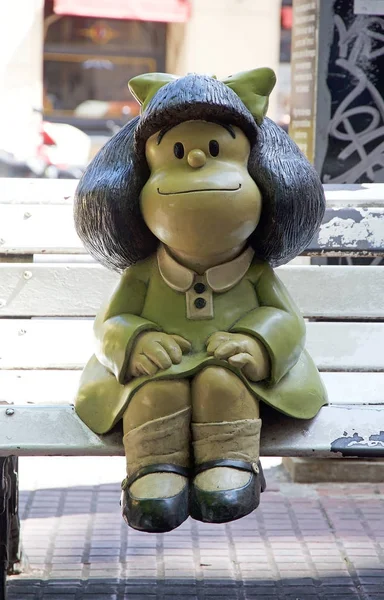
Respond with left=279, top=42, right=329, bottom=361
left=189, top=459, right=266, bottom=523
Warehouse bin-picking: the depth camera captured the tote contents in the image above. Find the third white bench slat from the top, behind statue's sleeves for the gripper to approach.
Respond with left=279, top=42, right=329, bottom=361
left=0, top=319, right=384, bottom=371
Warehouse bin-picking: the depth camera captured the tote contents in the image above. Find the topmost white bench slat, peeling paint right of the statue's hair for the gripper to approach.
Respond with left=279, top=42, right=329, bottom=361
left=0, top=179, right=384, bottom=255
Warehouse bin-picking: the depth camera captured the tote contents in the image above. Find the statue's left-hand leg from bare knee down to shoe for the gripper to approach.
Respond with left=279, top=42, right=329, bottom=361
left=122, top=380, right=191, bottom=532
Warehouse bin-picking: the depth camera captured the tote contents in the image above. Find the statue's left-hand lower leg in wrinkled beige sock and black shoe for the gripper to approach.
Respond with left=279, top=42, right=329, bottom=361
left=122, top=408, right=191, bottom=532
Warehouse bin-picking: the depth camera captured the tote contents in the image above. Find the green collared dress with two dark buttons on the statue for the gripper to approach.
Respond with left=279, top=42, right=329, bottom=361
left=75, top=246, right=327, bottom=433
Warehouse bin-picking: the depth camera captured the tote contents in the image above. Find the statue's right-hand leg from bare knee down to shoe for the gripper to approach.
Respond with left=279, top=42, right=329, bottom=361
left=190, top=366, right=265, bottom=523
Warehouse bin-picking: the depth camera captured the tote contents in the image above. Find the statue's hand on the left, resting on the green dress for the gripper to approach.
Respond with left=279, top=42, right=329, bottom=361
left=128, top=331, right=191, bottom=377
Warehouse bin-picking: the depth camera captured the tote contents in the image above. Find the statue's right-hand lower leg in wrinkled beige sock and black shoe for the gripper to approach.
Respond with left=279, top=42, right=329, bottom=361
left=190, top=419, right=265, bottom=523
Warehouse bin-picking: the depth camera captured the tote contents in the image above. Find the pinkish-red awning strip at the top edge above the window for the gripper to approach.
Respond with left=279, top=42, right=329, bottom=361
left=53, top=0, right=190, bottom=23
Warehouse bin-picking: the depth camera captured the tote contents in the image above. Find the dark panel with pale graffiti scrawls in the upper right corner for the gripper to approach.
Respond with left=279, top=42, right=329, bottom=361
left=322, top=0, right=384, bottom=183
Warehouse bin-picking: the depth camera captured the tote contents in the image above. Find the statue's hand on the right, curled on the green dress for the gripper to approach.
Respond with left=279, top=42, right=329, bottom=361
left=207, top=331, right=270, bottom=381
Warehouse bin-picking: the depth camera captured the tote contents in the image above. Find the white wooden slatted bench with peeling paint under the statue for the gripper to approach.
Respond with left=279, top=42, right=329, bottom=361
left=0, top=179, right=384, bottom=600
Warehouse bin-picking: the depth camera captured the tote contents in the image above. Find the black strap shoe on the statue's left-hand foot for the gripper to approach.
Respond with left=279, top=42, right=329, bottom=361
left=121, top=464, right=189, bottom=533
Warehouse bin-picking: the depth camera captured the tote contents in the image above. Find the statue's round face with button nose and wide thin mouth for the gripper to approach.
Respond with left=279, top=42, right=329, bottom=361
left=141, top=121, right=261, bottom=256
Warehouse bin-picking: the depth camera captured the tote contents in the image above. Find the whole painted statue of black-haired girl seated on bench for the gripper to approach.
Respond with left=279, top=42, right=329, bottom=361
left=75, top=69, right=326, bottom=532
